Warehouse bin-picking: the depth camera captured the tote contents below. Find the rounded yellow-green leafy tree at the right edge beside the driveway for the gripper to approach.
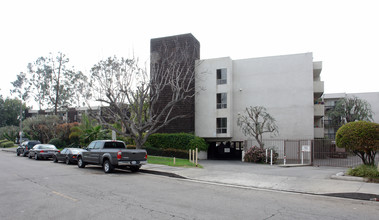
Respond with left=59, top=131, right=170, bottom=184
left=336, top=121, right=379, bottom=165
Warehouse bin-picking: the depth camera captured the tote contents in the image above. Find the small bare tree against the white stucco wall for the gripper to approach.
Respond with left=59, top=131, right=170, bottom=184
left=237, top=106, right=278, bottom=148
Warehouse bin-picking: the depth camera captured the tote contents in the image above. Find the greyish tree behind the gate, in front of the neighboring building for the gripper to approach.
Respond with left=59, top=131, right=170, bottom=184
left=327, top=96, right=373, bottom=125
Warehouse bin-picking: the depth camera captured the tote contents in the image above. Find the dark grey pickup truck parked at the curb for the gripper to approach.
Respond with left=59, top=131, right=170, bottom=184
left=78, top=140, right=147, bottom=173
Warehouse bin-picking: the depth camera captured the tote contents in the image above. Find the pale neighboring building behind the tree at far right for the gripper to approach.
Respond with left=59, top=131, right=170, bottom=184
left=322, top=92, right=379, bottom=140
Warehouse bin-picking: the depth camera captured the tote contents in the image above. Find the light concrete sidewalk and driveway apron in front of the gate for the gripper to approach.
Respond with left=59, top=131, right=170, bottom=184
left=142, top=160, right=379, bottom=199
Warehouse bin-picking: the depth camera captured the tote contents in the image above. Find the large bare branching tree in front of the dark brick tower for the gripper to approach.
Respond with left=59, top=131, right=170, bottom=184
left=91, top=42, right=202, bottom=148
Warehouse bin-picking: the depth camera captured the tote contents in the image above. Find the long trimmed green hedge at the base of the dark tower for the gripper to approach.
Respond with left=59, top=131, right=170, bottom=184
left=146, top=133, right=208, bottom=151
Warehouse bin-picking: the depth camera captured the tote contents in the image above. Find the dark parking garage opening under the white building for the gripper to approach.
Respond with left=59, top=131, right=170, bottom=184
left=208, top=141, right=243, bottom=160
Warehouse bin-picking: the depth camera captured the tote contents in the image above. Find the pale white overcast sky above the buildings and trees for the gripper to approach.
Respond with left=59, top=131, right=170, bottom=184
left=0, top=0, right=379, bottom=106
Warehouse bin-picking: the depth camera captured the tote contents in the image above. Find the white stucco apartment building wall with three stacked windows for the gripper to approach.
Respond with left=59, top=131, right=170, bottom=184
left=195, top=53, right=324, bottom=145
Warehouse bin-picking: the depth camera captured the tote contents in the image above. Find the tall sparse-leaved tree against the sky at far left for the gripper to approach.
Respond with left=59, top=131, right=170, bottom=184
left=28, top=52, right=87, bottom=114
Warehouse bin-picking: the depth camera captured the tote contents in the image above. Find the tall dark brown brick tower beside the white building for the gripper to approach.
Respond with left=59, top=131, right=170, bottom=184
left=150, top=34, right=200, bottom=133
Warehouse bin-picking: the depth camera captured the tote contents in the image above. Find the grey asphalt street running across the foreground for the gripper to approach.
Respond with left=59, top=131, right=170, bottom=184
left=0, top=152, right=379, bottom=219
